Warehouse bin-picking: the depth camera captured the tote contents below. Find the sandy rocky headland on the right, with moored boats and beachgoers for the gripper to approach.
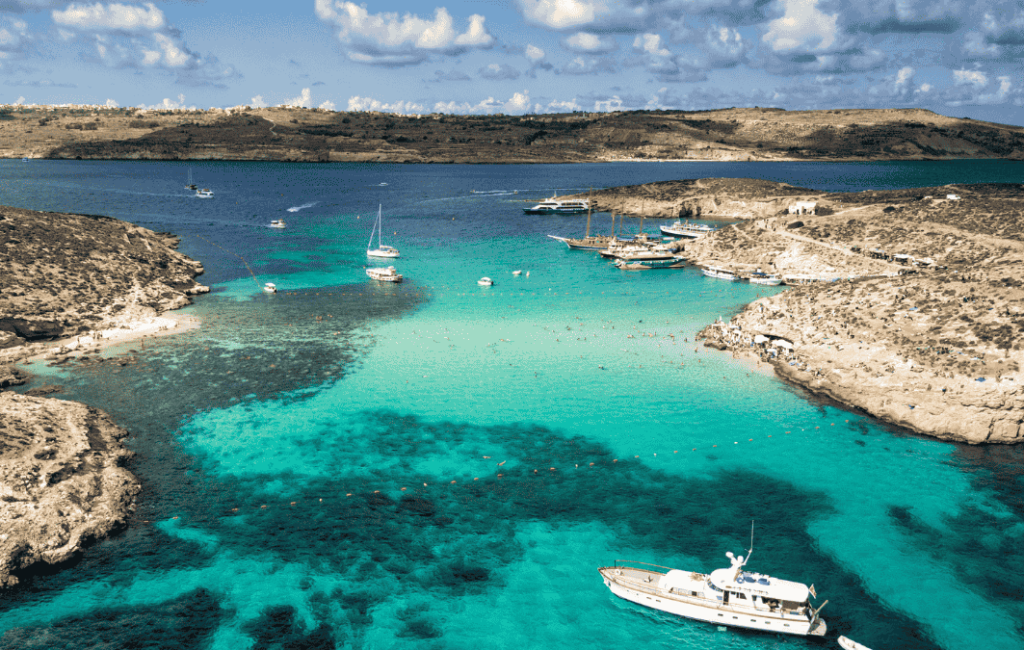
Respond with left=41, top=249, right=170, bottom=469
left=614, top=179, right=1024, bottom=443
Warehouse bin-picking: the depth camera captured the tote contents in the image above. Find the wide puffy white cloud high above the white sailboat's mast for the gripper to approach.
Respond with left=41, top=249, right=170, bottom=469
left=314, top=0, right=495, bottom=66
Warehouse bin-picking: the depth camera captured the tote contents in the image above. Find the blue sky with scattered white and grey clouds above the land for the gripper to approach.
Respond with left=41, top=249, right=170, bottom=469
left=0, top=0, right=1024, bottom=125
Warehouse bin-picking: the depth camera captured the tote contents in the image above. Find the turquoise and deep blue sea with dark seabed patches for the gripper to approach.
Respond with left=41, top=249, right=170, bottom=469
left=0, top=161, right=1024, bottom=650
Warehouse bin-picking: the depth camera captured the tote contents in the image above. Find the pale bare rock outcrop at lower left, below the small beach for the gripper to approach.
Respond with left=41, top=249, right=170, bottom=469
left=0, top=392, right=139, bottom=587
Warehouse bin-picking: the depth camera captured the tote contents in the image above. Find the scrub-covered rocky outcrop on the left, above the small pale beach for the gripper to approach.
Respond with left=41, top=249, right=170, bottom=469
left=0, top=207, right=209, bottom=348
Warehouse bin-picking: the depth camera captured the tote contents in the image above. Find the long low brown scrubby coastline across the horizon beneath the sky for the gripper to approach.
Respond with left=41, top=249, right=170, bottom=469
left=0, top=105, right=1024, bottom=163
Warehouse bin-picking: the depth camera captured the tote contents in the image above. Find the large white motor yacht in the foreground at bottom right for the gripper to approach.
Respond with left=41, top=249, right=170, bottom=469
left=598, top=552, right=828, bottom=637
